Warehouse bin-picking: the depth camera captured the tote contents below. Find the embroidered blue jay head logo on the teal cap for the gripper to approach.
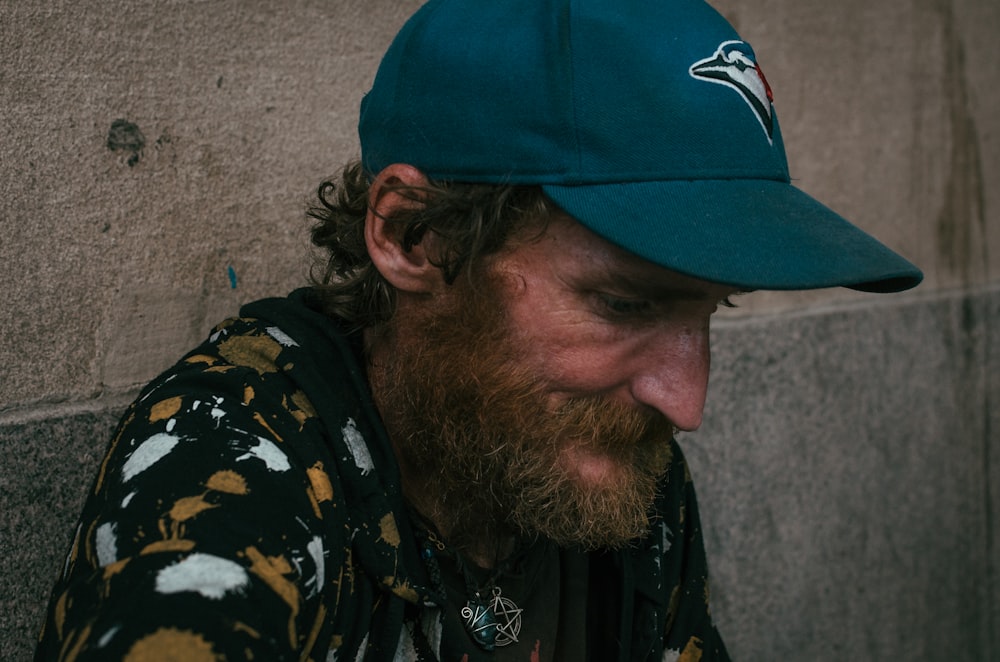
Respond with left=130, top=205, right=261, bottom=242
left=688, top=40, right=774, bottom=142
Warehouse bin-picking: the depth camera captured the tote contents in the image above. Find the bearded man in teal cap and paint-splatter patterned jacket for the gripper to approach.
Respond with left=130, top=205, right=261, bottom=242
left=38, top=0, right=921, bottom=661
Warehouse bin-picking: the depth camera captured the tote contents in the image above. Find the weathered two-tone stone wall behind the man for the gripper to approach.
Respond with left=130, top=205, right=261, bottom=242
left=0, top=0, right=1000, bottom=661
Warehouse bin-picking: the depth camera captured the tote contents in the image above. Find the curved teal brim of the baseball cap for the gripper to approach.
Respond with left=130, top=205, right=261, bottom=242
left=543, top=179, right=923, bottom=292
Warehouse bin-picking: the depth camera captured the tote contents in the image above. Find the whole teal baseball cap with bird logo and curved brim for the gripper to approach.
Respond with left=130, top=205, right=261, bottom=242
left=359, top=0, right=923, bottom=292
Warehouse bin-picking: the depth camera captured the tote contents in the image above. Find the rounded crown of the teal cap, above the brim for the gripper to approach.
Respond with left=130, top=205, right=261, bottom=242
left=359, top=0, right=788, bottom=184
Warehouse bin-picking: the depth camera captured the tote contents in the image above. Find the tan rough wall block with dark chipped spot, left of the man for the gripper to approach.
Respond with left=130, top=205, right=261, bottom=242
left=0, top=0, right=426, bottom=410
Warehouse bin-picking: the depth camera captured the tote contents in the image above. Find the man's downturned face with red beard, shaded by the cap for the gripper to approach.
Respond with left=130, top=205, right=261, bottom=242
left=374, top=217, right=733, bottom=547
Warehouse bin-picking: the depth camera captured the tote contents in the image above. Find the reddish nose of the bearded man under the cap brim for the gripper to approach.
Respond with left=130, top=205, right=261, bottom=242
left=630, top=324, right=711, bottom=431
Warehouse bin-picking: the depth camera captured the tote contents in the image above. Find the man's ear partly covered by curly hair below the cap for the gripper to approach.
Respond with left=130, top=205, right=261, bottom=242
left=365, top=163, right=444, bottom=293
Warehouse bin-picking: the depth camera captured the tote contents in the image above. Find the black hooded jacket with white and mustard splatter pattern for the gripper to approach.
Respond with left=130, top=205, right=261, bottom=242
left=36, top=289, right=728, bottom=662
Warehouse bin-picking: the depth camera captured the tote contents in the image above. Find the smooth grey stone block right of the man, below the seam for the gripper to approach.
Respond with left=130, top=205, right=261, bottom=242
left=685, top=289, right=1000, bottom=662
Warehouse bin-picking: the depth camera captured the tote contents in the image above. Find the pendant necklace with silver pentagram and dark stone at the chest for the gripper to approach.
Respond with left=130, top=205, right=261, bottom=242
left=427, top=531, right=524, bottom=652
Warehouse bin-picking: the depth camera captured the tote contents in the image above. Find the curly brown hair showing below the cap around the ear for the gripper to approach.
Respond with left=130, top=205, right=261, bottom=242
left=307, top=162, right=557, bottom=330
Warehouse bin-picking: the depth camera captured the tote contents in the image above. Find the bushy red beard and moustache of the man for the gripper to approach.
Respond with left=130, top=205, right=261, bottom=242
left=371, top=276, right=673, bottom=549
